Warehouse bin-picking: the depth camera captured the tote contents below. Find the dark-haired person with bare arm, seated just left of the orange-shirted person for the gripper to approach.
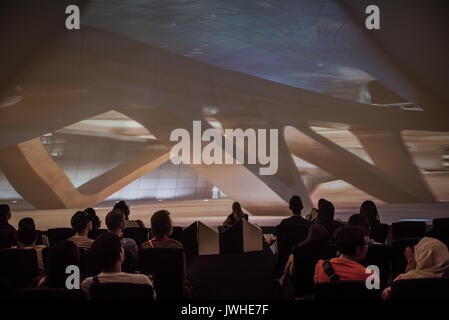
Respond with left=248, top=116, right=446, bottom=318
left=279, top=223, right=330, bottom=285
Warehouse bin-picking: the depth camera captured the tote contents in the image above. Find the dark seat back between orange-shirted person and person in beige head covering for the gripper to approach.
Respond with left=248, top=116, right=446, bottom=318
left=359, top=244, right=392, bottom=284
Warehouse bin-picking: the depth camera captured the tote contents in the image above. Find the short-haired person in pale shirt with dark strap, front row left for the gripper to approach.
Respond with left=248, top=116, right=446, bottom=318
left=81, top=232, right=153, bottom=297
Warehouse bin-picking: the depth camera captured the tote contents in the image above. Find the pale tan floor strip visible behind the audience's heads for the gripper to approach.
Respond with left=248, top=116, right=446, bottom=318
left=10, top=199, right=449, bottom=230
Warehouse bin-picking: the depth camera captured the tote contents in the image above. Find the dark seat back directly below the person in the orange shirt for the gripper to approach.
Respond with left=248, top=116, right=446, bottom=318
left=315, top=281, right=381, bottom=301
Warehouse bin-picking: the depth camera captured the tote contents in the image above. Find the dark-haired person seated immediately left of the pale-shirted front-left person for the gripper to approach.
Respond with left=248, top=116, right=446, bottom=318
left=37, top=240, right=80, bottom=289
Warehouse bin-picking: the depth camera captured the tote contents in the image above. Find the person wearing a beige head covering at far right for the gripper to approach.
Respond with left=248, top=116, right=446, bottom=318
left=382, top=237, right=449, bottom=299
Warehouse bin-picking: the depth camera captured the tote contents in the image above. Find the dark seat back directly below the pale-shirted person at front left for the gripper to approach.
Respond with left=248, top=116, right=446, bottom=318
left=89, top=282, right=154, bottom=300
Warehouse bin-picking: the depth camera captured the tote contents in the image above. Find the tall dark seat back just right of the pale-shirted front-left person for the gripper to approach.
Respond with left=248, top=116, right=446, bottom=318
left=139, top=248, right=184, bottom=300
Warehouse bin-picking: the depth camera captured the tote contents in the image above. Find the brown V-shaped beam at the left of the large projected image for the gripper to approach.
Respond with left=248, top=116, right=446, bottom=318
left=0, top=138, right=170, bottom=209
